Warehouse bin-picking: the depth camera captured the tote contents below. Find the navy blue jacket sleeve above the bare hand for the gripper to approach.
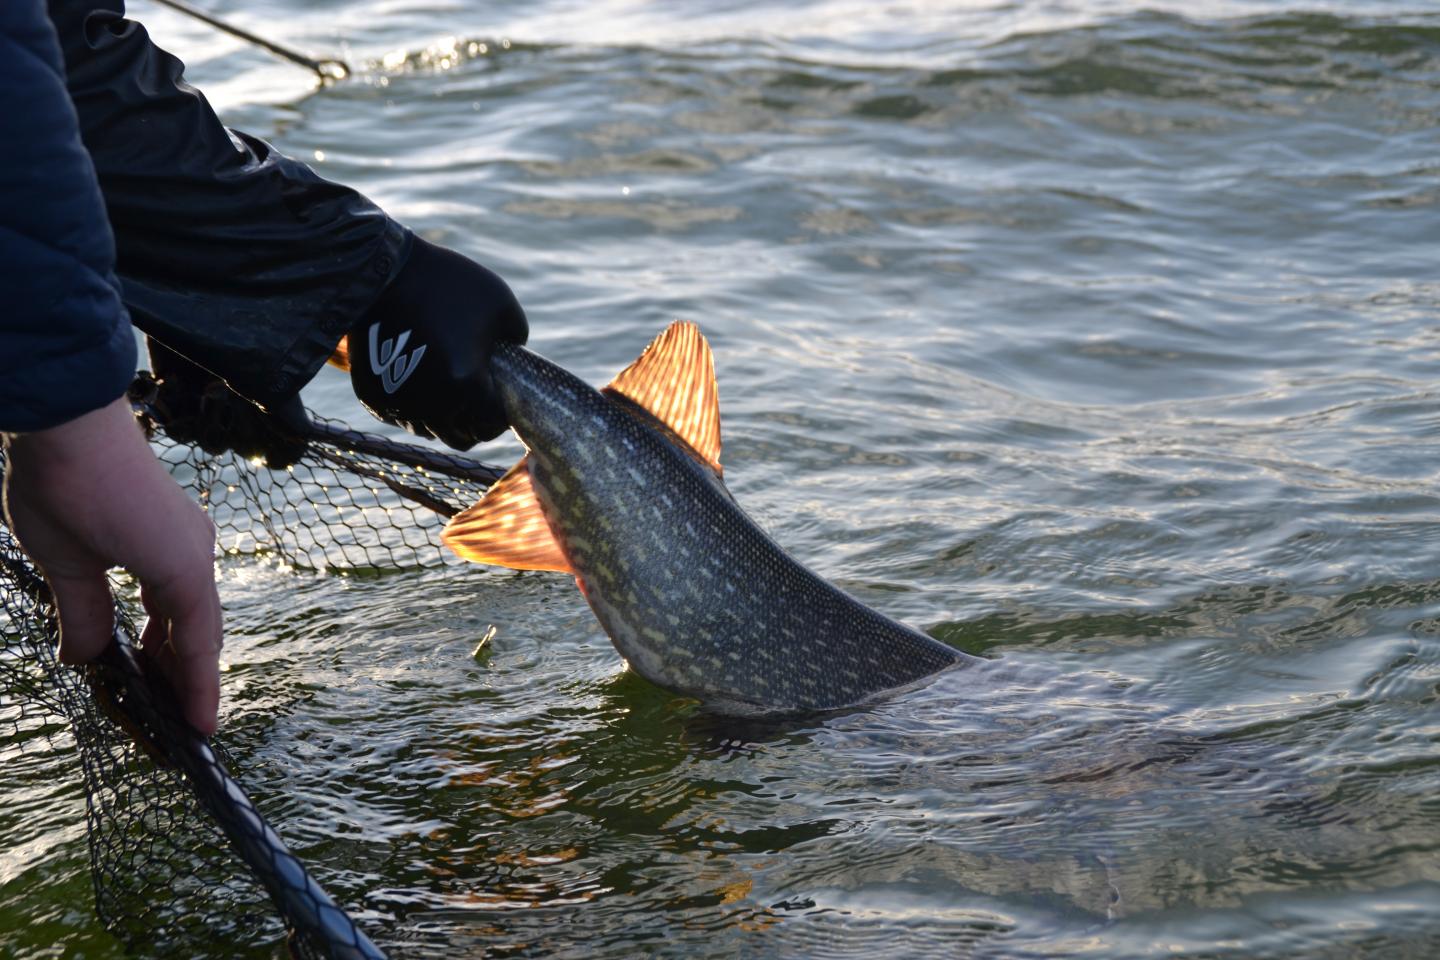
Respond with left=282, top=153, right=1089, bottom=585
left=0, top=0, right=135, bottom=432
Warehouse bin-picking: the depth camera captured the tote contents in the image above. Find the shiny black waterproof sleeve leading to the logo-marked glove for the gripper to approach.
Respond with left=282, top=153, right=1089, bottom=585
left=49, top=0, right=410, bottom=407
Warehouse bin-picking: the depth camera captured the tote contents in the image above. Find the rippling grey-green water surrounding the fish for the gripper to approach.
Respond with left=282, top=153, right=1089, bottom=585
left=0, top=0, right=1440, bottom=957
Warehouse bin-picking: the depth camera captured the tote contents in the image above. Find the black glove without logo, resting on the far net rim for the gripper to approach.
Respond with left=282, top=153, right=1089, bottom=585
left=148, top=340, right=310, bottom=471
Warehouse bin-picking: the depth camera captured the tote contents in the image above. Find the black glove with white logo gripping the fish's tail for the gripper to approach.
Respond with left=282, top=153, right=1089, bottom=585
left=350, top=237, right=530, bottom=450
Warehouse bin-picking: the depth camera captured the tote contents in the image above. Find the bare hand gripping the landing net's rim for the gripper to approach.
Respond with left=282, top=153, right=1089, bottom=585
left=4, top=397, right=220, bottom=734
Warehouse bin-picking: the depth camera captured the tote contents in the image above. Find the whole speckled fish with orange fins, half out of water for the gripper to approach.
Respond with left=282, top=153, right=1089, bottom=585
left=441, top=321, right=988, bottom=717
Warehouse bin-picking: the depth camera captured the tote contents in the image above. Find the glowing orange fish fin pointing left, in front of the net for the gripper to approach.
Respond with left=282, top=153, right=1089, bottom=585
left=441, top=455, right=573, bottom=573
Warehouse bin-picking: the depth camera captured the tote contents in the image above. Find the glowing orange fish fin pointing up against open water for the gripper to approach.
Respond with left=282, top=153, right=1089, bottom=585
left=605, top=321, right=720, bottom=472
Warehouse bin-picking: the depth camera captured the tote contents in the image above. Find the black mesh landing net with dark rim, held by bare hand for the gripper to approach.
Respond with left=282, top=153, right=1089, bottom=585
left=0, top=385, right=500, bottom=959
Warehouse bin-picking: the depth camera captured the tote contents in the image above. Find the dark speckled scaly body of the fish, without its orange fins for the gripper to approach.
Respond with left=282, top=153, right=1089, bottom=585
left=491, top=339, right=982, bottom=715
